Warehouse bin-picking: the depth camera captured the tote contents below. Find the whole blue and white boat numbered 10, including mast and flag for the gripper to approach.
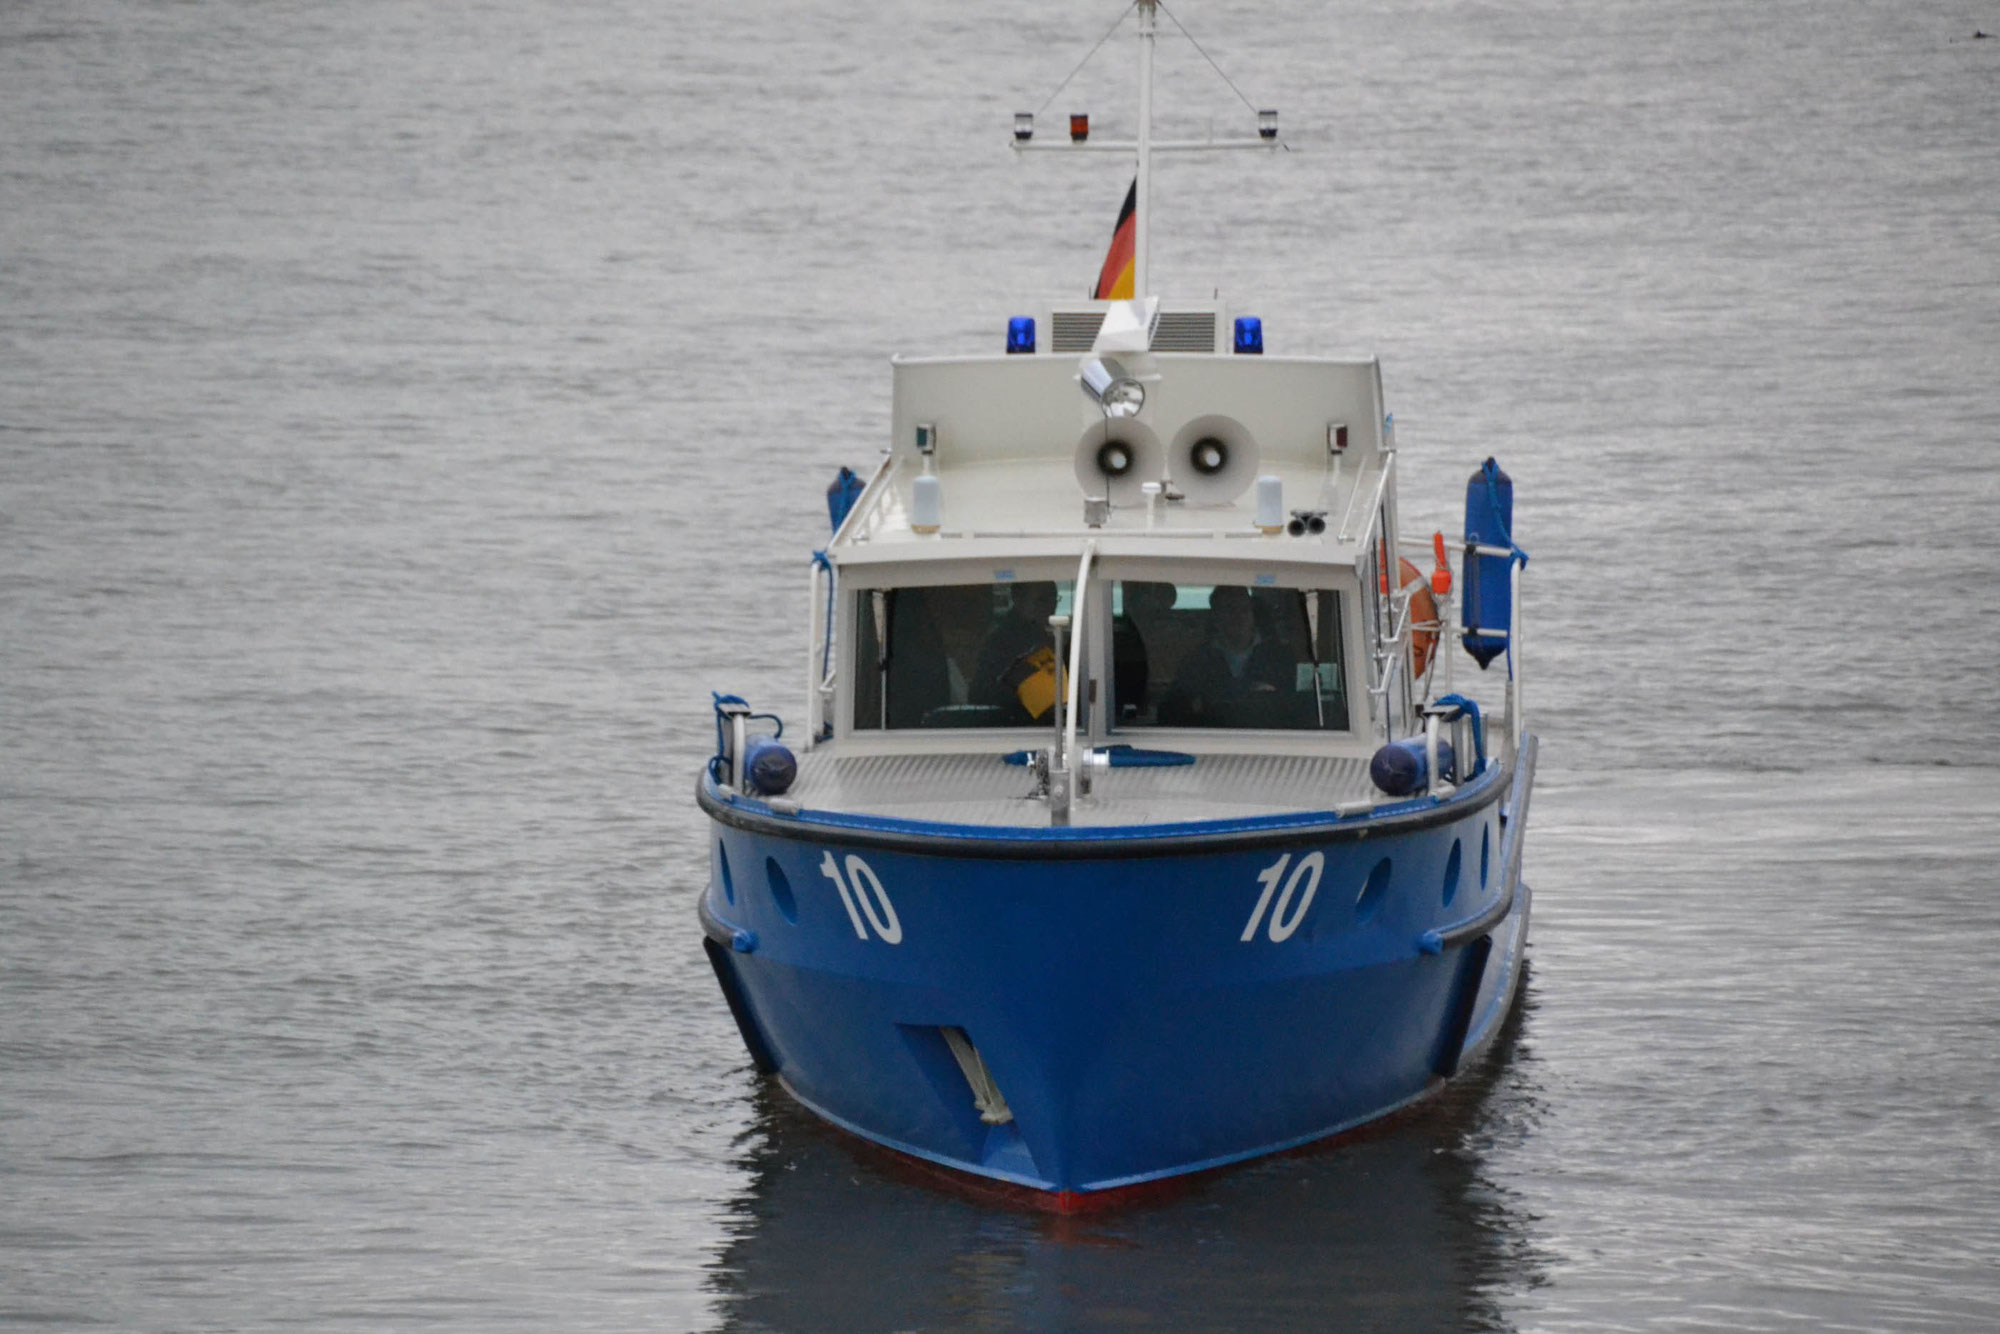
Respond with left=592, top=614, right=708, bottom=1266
left=696, top=0, right=1536, bottom=1212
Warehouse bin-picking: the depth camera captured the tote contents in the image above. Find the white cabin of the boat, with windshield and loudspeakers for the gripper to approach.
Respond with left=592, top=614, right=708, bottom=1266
left=806, top=298, right=1440, bottom=804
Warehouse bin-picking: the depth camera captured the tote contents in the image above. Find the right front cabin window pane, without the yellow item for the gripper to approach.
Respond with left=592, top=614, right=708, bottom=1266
left=1112, top=580, right=1348, bottom=732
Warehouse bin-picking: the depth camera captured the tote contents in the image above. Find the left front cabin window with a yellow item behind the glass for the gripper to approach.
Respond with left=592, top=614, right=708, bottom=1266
left=850, top=580, right=1072, bottom=730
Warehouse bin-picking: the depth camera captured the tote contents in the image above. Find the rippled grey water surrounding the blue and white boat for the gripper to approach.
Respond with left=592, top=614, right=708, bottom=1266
left=0, top=0, right=2000, bottom=1330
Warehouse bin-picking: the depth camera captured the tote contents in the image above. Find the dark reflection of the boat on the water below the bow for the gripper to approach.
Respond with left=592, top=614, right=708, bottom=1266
left=712, top=988, right=1540, bottom=1330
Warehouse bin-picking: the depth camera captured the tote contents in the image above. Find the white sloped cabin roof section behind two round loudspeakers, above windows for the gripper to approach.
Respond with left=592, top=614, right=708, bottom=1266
left=830, top=336, right=1392, bottom=564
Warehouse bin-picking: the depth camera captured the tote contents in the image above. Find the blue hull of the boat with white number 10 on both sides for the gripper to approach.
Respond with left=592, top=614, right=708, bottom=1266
left=700, top=748, right=1534, bottom=1194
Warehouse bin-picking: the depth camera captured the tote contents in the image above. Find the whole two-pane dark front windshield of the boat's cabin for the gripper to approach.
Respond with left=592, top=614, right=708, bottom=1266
left=854, top=580, right=1348, bottom=732
